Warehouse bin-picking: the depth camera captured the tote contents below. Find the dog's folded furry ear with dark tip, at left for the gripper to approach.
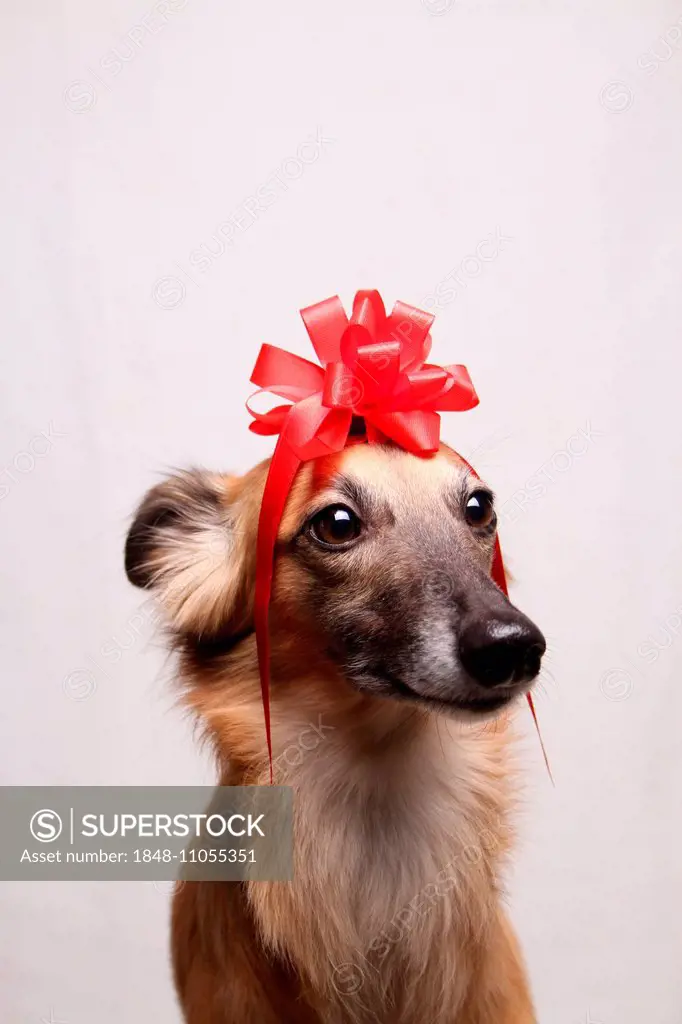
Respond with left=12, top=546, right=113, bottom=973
left=125, top=467, right=264, bottom=637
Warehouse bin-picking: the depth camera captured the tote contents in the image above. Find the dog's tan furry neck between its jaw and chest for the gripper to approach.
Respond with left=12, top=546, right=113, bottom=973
left=201, top=638, right=509, bottom=807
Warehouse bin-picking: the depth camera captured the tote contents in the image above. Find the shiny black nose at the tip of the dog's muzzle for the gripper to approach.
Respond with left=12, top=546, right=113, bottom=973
left=460, top=615, right=547, bottom=686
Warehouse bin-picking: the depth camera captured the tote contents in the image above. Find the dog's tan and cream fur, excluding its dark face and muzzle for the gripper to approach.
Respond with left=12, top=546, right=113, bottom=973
left=125, top=445, right=536, bottom=1024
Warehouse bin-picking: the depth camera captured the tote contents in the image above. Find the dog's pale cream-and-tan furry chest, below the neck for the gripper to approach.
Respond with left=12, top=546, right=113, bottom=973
left=248, top=724, right=501, bottom=1021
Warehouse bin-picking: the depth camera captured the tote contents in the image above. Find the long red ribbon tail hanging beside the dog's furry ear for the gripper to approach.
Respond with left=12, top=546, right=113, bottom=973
left=254, top=431, right=301, bottom=785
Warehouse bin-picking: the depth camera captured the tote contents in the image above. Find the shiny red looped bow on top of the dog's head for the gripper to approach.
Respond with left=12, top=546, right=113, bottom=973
left=249, top=292, right=478, bottom=462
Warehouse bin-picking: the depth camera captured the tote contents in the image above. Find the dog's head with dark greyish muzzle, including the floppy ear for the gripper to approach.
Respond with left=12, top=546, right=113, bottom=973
left=126, top=443, right=545, bottom=715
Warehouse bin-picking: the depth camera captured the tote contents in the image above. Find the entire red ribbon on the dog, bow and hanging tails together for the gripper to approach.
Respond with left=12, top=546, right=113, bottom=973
left=247, top=291, right=549, bottom=782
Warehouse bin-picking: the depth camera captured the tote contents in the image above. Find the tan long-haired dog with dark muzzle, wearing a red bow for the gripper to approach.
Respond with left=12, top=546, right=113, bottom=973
left=126, top=442, right=545, bottom=1024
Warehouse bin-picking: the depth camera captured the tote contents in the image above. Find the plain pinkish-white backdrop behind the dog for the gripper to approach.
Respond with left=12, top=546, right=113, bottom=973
left=0, top=0, right=682, bottom=1024
